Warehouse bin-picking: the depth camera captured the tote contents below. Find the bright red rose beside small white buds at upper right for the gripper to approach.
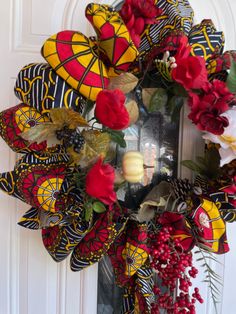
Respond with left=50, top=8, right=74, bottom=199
left=171, top=51, right=208, bottom=91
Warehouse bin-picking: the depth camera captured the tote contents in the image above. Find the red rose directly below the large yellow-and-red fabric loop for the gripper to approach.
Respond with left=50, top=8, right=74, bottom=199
left=95, top=89, right=129, bottom=130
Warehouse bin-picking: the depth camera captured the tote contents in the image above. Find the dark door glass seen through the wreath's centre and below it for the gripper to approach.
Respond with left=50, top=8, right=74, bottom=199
left=97, top=93, right=179, bottom=314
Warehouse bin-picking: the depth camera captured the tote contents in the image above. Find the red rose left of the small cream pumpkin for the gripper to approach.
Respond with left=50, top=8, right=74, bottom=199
left=85, top=158, right=116, bottom=205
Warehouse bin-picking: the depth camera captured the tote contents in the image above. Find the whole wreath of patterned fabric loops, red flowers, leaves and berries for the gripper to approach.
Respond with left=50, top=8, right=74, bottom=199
left=0, top=0, right=236, bottom=314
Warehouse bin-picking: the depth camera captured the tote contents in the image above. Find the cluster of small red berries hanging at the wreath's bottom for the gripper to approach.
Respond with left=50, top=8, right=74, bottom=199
left=149, top=227, right=203, bottom=314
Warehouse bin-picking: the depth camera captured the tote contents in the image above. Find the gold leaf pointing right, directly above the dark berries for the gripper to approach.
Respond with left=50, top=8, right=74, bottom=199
left=50, top=108, right=88, bottom=129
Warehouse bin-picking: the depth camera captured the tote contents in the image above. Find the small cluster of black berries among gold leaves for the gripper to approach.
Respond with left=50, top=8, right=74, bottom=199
left=56, top=126, right=85, bottom=153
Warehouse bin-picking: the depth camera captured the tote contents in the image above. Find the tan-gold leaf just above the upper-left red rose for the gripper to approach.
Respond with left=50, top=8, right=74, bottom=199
left=108, top=73, right=138, bottom=94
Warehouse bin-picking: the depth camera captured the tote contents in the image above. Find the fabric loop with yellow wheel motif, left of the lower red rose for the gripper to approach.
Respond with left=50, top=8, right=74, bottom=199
left=0, top=152, right=68, bottom=212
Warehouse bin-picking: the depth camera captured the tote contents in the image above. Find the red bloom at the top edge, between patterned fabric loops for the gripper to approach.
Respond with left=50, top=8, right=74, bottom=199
left=119, top=0, right=162, bottom=47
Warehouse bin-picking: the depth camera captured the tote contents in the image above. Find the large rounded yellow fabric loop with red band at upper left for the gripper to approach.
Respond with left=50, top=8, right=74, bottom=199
left=42, top=30, right=109, bottom=101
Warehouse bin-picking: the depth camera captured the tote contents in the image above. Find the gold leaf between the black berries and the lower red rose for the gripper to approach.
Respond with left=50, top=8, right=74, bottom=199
left=68, top=130, right=110, bottom=167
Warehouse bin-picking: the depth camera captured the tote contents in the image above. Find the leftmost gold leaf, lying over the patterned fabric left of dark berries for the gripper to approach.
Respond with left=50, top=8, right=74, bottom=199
left=20, top=122, right=57, bottom=143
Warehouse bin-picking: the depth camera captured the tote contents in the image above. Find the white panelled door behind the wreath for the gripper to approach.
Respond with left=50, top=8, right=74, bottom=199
left=0, top=0, right=236, bottom=314
